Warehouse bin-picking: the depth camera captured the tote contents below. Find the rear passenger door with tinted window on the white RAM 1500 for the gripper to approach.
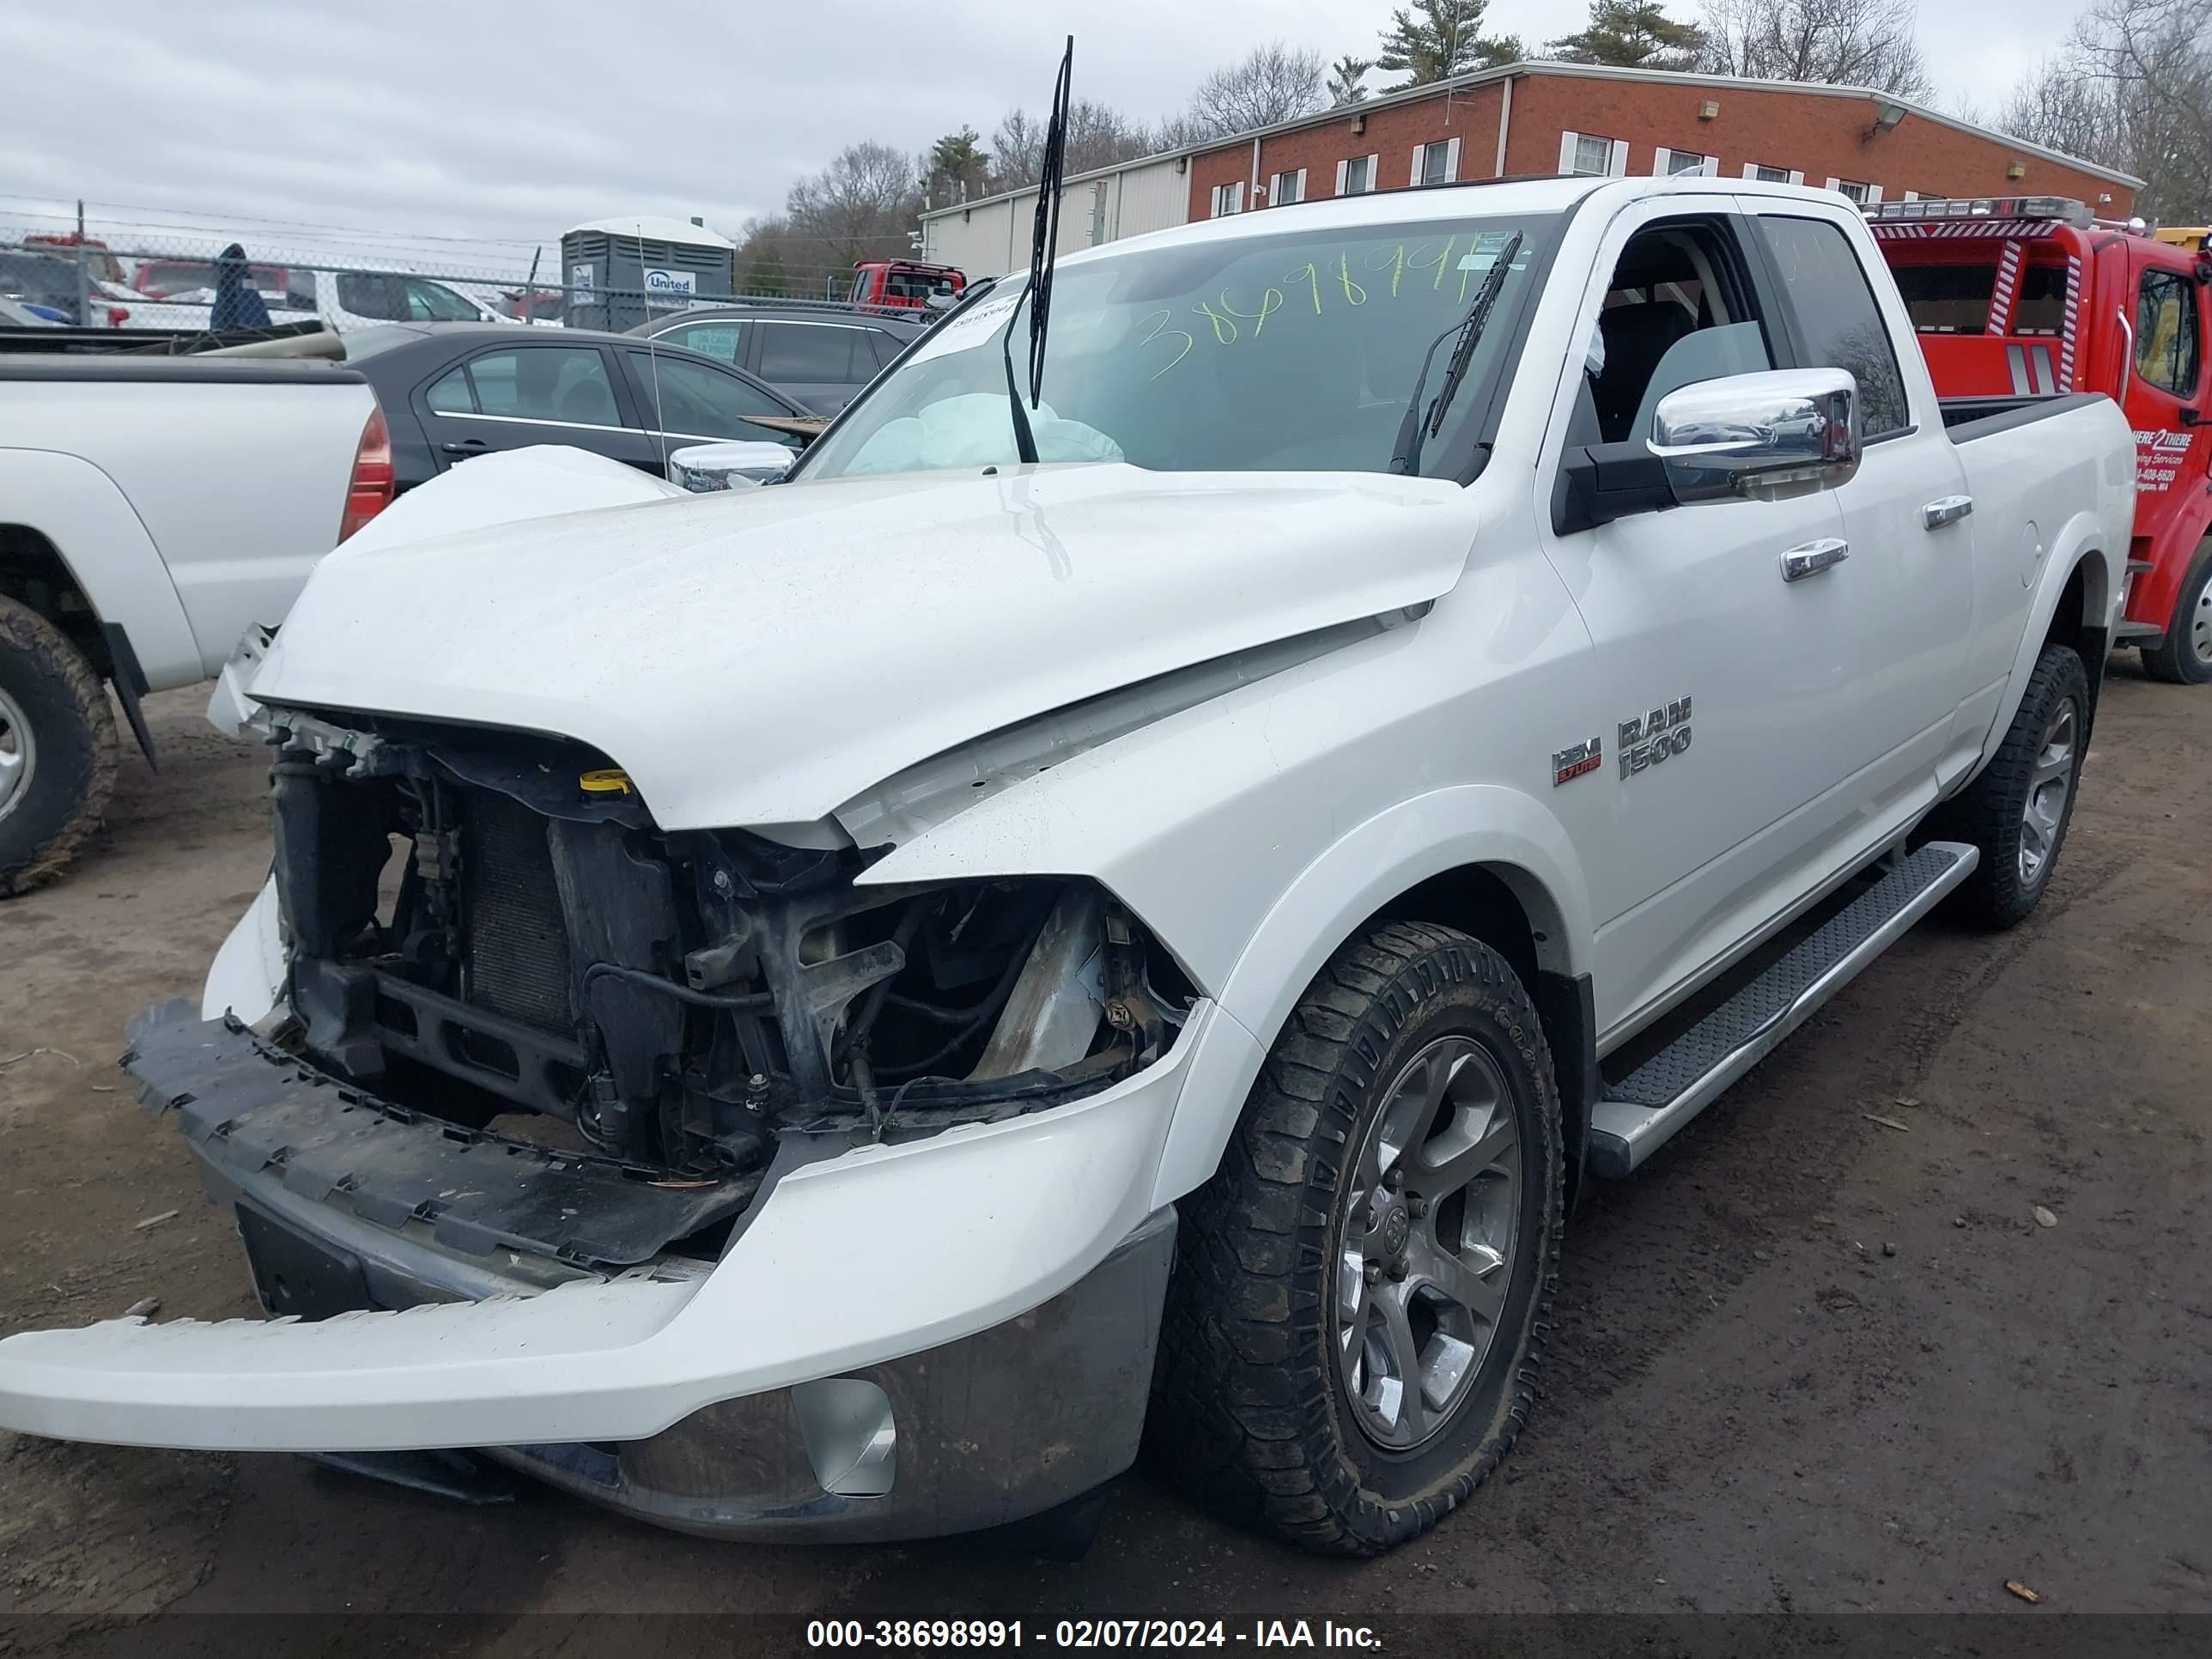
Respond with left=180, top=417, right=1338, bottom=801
left=1745, top=197, right=1990, bottom=792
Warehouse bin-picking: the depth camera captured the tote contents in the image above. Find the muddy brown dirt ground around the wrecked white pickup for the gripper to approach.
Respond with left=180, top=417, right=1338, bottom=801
left=0, top=659, right=2212, bottom=1655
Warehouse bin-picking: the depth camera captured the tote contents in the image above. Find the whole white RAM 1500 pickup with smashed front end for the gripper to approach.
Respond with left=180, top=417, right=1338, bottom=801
left=0, top=179, right=2132, bottom=1553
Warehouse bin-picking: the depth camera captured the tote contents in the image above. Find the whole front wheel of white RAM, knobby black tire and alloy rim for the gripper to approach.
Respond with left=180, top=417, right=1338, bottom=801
left=1148, top=922, right=1562, bottom=1555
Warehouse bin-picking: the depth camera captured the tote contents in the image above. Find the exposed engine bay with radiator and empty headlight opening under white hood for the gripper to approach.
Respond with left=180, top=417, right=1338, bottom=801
left=268, top=708, right=1194, bottom=1256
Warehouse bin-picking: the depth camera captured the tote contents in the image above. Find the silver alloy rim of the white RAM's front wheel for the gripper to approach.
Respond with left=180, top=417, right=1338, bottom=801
left=1332, top=1037, right=1522, bottom=1451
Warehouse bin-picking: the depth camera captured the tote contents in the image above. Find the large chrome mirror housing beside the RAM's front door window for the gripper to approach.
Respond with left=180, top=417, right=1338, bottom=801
left=1646, top=369, right=1860, bottom=504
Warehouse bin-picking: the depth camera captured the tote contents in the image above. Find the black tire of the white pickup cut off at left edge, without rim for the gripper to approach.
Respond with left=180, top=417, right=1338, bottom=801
left=0, top=599, right=118, bottom=898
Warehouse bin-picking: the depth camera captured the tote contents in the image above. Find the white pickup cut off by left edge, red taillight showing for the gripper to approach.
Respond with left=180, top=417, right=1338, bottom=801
left=0, top=354, right=392, bottom=898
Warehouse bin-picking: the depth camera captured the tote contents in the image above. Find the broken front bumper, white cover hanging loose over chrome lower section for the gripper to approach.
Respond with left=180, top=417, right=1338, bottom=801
left=0, top=1002, right=1214, bottom=1540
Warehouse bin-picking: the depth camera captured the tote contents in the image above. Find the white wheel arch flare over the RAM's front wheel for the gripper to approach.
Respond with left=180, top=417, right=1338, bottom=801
left=1152, top=783, right=1593, bottom=1206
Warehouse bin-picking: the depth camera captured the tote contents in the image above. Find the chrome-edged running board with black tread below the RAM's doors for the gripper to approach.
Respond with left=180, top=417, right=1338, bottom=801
left=1589, top=841, right=1982, bottom=1176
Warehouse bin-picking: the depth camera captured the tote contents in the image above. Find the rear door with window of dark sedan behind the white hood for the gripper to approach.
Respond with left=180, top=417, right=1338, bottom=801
left=414, top=344, right=661, bottom=473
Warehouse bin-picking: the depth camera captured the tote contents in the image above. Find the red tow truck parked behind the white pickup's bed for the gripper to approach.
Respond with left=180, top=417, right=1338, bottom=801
left=1867, top=197, right=2212, bottom=686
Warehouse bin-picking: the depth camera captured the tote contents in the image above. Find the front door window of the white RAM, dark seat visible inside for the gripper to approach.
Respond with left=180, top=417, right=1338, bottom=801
left=1566, top=222, right=1774, bottom=455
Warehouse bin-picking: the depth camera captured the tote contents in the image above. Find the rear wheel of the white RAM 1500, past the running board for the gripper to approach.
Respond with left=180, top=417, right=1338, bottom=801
left=1947, top=646, right=2088, bottom=927
